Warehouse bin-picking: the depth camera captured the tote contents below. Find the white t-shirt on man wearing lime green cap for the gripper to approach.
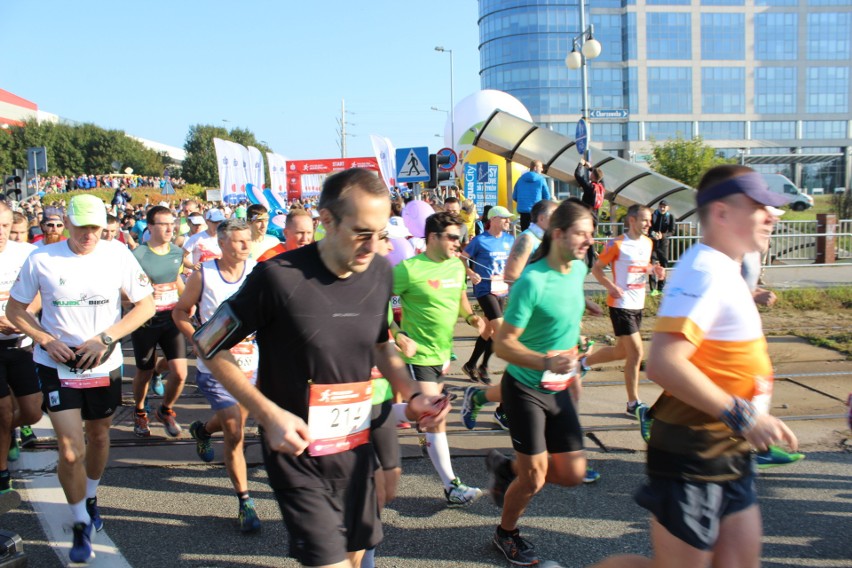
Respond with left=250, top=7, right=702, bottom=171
left=11, top=240, right=154, bottom=370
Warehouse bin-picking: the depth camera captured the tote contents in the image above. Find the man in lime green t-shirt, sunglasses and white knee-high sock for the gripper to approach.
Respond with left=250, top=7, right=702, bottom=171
left=393, top=212, right=485, bottom=507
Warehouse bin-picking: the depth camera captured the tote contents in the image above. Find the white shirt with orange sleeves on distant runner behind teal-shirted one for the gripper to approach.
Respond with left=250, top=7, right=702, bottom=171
left=598, top=233, right=652, bottom=310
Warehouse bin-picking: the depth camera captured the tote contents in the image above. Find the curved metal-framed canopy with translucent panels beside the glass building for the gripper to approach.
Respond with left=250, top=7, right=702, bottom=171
left=473, top=109, right=700, bottom=221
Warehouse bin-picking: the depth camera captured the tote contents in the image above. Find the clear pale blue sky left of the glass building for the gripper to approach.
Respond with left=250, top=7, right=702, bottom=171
left=0, top=0, right=480, bottom=159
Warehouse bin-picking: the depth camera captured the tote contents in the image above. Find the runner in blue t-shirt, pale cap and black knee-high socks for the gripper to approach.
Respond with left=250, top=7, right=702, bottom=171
left=462, top=206, right=515, bottom=385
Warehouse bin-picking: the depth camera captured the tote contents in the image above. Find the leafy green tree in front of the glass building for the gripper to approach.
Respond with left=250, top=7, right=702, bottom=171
left=650, top=136, right=735, bottom=187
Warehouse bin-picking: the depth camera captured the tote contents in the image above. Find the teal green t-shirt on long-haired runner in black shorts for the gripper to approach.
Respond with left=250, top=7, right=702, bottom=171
left=504, top=259, right=588, bottom=392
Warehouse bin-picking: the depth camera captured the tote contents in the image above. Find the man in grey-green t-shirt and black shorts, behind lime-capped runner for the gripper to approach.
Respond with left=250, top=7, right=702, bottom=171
left=130, top=205, right=187, bottom=438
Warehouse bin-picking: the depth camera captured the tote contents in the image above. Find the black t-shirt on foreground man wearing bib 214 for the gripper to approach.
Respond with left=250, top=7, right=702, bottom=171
left=220, top=243, right=393, bottom=489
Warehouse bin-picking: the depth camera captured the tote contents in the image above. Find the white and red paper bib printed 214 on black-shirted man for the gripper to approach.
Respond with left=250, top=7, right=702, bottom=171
left=308, top=381, right=373, bottom=457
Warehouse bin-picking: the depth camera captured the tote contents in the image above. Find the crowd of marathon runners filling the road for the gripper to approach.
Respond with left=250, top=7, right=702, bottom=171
left=0, top=162, right=832, bottom=568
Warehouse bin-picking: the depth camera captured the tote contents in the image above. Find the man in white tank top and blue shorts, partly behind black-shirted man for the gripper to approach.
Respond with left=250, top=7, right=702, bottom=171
left=172, top=219, right=260, bottom=532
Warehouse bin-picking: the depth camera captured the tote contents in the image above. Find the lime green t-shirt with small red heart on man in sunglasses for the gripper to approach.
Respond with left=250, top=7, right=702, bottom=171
left=393, top=253, right=465, bottom=366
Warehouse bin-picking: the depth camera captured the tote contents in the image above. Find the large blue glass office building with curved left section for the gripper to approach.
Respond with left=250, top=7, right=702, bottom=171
left=479, top=0, right=852, bottom=193
